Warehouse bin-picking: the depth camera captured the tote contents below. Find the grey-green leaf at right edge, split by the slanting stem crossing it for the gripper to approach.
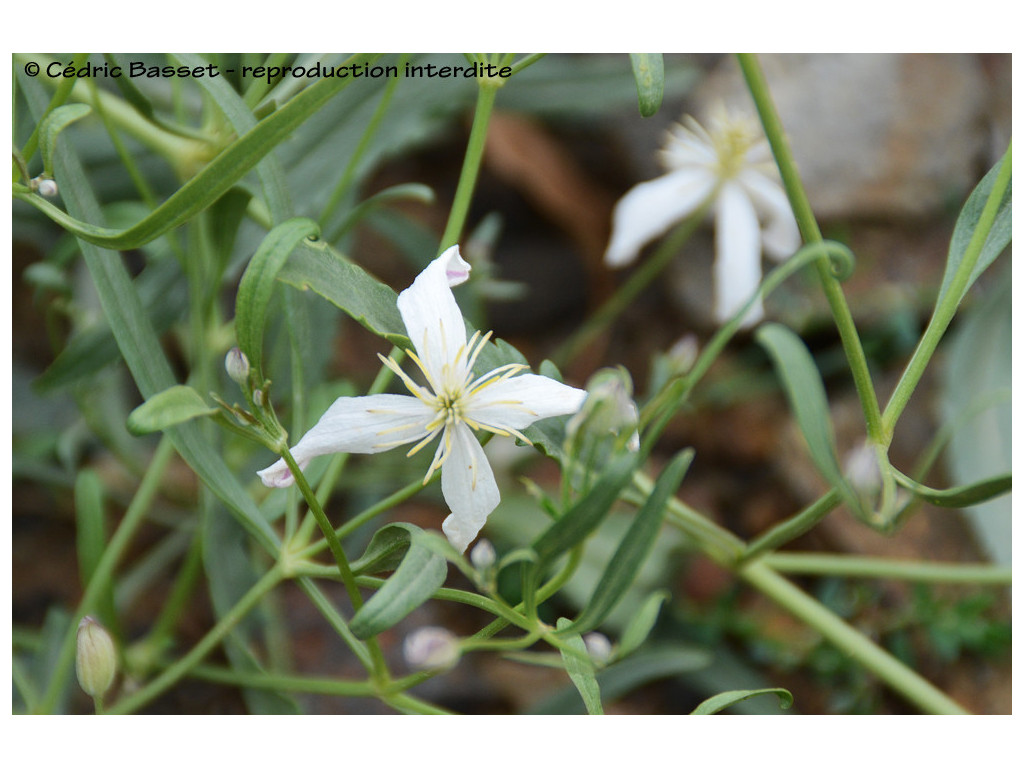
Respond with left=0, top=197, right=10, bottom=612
left=936, top=157, right=1013, bottom=305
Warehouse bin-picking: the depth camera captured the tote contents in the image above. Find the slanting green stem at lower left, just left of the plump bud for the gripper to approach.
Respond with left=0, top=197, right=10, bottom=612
left=38, top=436, right=174, bottom=713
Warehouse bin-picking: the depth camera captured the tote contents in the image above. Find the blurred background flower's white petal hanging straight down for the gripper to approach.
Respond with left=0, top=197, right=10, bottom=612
left=715, top=183, right=764, bottom=326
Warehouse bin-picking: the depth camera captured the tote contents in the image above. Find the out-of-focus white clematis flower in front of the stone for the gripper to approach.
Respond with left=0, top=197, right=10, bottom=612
left=604, top=110, right=800, bottom=326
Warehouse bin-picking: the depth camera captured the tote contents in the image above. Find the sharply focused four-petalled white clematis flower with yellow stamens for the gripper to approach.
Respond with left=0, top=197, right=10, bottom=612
left=259, top=246, right=587, bottom=552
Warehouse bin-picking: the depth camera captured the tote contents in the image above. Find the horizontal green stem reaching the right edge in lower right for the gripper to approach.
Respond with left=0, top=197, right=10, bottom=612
left=764, top=552, right=1013, bottom=585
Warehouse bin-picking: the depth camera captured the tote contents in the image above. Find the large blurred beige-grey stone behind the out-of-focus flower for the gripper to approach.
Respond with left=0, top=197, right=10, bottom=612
left=694, top=53, right=995, bottom=218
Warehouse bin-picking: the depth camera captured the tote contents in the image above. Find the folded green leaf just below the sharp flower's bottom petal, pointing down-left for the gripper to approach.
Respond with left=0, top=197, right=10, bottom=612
left=349, top=537, right=447, bottom=640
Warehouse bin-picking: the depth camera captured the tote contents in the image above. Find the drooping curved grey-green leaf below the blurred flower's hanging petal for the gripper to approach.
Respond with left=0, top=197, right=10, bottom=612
left=755, top=323, right=860, bottom=509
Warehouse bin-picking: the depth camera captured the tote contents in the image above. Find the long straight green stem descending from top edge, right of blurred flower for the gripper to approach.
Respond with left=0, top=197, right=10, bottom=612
left=737, top=53, right=888, bottom=445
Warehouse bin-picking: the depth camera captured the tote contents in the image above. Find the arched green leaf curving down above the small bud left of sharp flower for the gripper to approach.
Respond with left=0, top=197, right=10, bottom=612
left=234, top=218, right=319, bottom=380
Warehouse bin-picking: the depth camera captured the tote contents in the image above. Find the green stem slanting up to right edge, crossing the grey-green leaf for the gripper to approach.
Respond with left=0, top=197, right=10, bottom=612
left=882, top=145, right=1013, bottom=444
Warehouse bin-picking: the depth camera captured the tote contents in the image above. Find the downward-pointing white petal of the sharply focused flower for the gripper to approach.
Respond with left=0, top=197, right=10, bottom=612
left=441, top=424, right=501, bottom=552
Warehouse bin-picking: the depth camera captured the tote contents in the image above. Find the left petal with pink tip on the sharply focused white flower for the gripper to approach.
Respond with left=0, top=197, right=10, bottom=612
left=257, top=394, right=434, bottom=488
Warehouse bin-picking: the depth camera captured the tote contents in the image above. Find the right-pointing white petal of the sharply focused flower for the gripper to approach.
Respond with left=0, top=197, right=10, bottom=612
left=466, top=374, right=587, bottom=430
